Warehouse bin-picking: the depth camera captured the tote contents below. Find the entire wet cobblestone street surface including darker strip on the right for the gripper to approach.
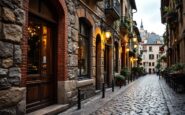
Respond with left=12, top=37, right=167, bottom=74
left=60, top=75, right=185, bottom=115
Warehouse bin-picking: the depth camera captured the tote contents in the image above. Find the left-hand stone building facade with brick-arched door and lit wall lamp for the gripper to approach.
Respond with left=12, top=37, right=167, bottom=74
left=0, top=0, right=139, bottom=115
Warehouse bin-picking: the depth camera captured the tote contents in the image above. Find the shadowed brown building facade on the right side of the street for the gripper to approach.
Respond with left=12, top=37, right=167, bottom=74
left=161, top=0, right=185, bottom=66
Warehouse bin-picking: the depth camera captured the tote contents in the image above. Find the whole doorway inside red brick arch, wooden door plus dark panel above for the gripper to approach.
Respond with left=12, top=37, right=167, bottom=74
left=26, top=0, right=58, bottom=112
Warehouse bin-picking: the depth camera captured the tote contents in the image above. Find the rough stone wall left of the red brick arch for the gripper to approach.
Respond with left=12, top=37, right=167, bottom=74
left=0, top=0, right=25, bottom=115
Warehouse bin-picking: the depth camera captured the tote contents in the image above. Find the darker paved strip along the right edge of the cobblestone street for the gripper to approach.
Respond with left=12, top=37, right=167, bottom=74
left=160, top=79, right=185, bottom=115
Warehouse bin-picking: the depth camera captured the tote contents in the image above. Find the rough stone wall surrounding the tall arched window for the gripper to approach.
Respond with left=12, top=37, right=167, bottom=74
left=63, top=0, right=103, bottom=105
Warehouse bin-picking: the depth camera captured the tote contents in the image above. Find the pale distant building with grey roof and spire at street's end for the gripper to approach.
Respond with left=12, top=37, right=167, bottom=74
left=139, top=21, right=163, bottom=74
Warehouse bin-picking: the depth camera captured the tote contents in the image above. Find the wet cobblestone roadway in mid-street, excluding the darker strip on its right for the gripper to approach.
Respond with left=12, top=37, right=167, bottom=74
left=90, top=75, right=169, bottom=115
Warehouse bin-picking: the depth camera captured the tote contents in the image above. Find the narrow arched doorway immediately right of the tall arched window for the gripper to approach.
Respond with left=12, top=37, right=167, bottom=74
left=96, top=35, right=101, bottom=90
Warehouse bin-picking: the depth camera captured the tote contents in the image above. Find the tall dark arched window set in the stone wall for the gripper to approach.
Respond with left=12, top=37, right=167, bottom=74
left=78, top=18, right=90, bottom=79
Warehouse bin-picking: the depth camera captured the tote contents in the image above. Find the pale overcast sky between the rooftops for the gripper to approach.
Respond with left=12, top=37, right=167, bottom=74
left=134, top=0, right=165, bottom=36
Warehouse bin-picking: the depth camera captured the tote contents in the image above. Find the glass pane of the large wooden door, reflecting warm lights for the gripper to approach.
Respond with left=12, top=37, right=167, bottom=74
left=27, top=19, right=51, bottom=76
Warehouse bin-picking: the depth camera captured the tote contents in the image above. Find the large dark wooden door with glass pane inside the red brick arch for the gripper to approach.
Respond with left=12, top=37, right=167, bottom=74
left=26, top=16, right=56, bottom=112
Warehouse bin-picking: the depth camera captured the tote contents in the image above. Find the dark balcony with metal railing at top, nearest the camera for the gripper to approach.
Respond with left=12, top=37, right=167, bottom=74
left=105, top=0, right=121, bottom=20
